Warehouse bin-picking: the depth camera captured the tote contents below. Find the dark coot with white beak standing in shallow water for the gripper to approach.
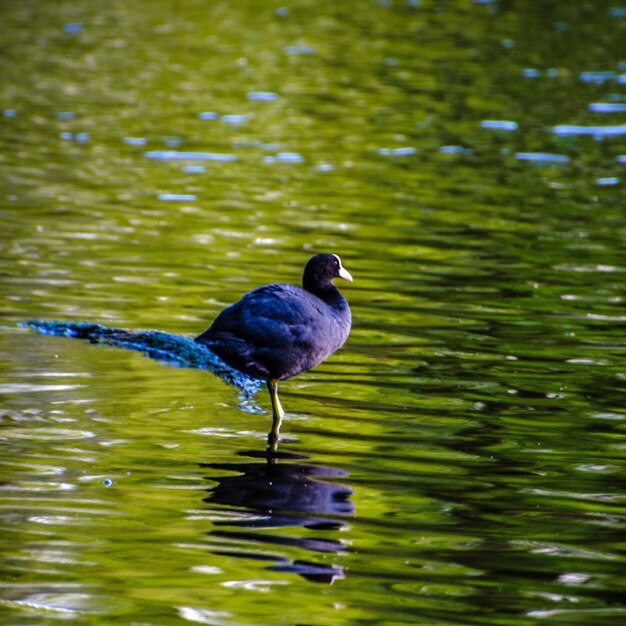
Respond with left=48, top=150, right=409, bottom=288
left=196, top=254, right=352, bottom=451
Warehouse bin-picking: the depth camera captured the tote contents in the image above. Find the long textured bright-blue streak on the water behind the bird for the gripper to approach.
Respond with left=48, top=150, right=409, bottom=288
left=20, top=320, right=261, bottom=398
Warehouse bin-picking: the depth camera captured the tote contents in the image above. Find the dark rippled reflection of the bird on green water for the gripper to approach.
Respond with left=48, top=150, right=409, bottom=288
left=201, top=453, right=355, bottom=583
